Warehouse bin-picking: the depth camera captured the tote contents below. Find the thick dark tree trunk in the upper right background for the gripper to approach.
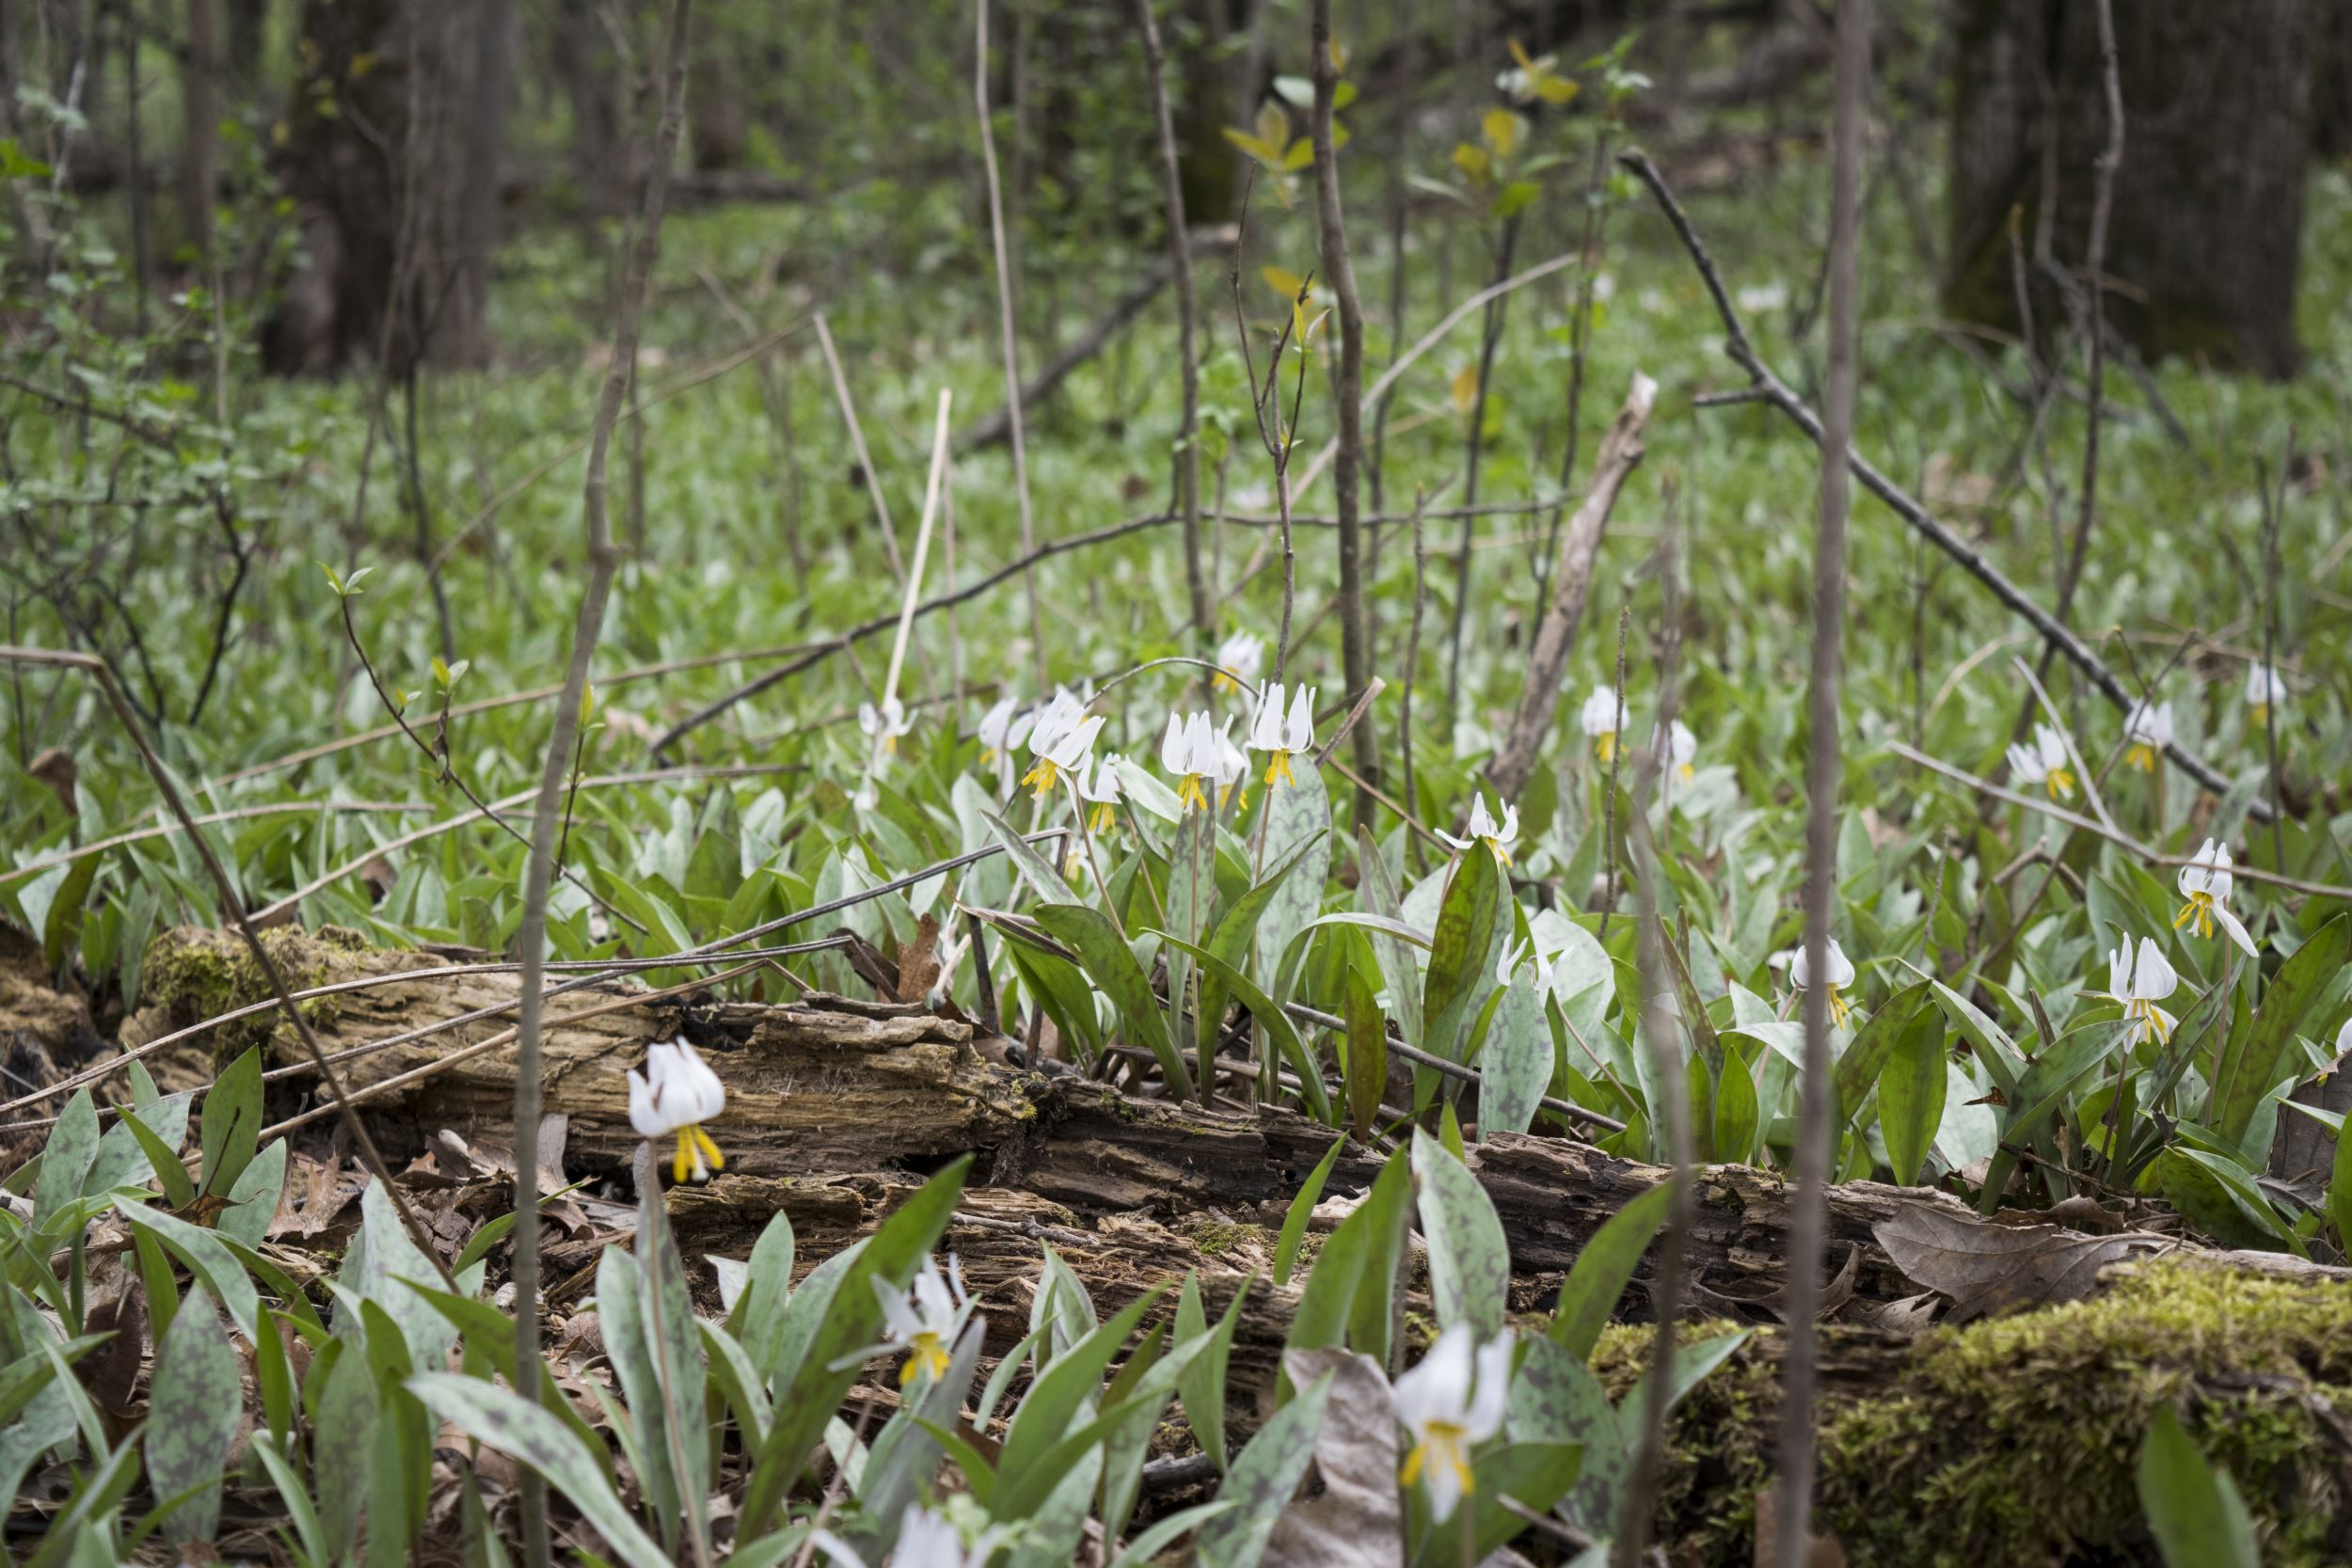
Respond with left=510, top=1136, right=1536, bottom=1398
left=1946, top=0, right=2319, bottom=376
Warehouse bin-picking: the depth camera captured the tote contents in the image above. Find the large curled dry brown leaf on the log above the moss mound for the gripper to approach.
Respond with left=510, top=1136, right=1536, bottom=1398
left=1872, top=1204, right=2162, bottom=1323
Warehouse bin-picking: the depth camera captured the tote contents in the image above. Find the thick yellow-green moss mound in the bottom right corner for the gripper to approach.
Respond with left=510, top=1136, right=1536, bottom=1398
left=1595, top=1260, right=2352, bottom=1568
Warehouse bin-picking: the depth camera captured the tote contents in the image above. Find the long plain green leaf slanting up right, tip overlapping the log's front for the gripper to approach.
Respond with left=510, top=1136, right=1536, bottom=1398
left=737, top=1154, right=972, bottom=1540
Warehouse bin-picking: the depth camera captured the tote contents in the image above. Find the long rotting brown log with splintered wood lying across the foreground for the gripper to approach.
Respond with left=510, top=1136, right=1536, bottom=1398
left=141, top=931, right=2352, bottom=1322
